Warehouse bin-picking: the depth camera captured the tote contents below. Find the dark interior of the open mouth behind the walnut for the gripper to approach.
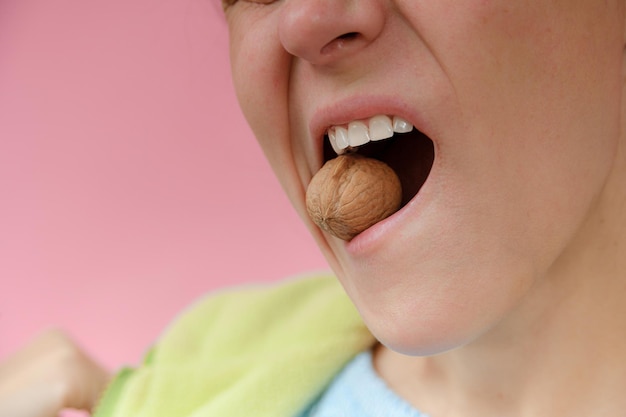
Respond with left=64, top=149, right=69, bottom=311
left=324, top=116, right=435, bottom=207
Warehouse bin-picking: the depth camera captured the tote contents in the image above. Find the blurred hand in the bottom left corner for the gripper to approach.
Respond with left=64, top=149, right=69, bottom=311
left=0, top=330, right=110, bottom=417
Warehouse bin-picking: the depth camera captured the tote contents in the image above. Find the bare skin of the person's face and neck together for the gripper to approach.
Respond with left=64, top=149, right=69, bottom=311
left=226, top=0, right=626, bottom=417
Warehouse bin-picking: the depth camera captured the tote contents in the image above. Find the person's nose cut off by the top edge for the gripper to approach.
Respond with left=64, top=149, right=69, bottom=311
left=278, top=0, right=385, bottom=65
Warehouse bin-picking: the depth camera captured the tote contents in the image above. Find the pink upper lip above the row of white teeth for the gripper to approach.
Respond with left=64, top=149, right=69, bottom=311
left=309, top=96, right=425, bottom=168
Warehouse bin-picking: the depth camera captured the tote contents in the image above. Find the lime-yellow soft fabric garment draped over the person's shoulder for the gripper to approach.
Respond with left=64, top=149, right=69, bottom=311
left=94, top=276, right=375, bottom=417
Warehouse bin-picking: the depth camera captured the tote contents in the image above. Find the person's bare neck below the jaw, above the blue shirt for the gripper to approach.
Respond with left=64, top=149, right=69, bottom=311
left=375, top=144, right=626, bottom=417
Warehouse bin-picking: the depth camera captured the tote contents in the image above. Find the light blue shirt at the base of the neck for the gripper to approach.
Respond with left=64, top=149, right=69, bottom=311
left=300, top=351, right=428, bottom=417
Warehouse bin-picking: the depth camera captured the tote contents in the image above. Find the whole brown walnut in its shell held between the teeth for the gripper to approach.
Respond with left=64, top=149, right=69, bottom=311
left=306, top=154, right=402, bottom=241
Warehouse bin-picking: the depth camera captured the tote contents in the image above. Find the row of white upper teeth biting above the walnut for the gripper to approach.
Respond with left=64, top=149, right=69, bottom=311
left=326, top=114, right=413, bottom=155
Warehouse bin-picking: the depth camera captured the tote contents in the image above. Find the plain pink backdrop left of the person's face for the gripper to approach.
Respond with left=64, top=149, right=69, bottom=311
left=0, top=0, right=326, bottom=368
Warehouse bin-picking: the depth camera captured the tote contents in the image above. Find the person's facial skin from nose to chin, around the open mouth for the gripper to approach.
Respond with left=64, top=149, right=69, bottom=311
left=226, top=0, right=624, bottom=355
